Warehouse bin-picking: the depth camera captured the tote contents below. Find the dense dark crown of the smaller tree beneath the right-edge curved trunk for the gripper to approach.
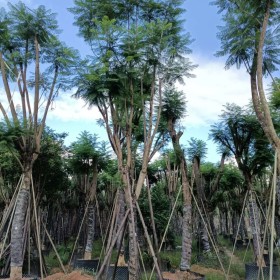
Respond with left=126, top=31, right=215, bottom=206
left=210, top=104, right=273, bottom=179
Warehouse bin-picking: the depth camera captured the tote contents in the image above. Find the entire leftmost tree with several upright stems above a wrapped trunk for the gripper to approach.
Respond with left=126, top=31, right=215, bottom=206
left=0, top=2, right=78, bottom=279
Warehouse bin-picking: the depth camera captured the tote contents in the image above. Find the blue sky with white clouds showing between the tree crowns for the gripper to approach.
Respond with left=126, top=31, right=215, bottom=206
left=0, top=0, right=258, bottom=162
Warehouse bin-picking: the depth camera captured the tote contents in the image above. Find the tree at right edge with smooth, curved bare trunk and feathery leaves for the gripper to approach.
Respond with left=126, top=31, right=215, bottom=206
left=213, top=0, right=280, bottom=248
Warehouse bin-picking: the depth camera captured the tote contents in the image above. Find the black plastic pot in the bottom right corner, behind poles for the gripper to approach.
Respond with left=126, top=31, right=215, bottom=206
left=245, top=263, right=280, bottom=280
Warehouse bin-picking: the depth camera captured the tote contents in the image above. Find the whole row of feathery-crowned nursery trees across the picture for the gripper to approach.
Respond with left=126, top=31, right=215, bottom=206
left=0, top=0, right=280, bottom=279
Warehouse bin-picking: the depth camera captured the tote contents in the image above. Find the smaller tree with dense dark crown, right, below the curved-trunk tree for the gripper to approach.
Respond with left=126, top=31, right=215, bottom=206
left=210, top=104, right=272, bottom=266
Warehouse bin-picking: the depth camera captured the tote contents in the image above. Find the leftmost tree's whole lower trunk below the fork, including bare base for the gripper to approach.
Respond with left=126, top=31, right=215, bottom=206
left=10, top=170, right=31, bottom=280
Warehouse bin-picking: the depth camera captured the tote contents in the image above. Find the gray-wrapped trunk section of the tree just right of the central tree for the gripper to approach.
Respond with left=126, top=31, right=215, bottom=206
left=180, top=205, right=192, bottom=271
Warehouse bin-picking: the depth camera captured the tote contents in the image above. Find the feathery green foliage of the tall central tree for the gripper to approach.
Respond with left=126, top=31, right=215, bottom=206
left=70, top=0, right=194, bottom=162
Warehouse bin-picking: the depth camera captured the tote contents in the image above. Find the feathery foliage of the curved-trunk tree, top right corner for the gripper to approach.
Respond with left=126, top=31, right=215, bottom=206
left=212, top=0, right=280, bottom=73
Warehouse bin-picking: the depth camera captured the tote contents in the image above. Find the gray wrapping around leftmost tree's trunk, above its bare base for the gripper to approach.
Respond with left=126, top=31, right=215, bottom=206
left=11, top=189, right=30, bottom=267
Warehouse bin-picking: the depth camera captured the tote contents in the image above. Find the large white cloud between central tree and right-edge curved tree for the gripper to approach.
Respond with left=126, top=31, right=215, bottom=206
left=179, top=54, right=270, bottom=127
